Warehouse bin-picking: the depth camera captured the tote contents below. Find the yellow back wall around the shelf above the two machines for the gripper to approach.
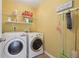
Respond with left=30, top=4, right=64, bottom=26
left=3, top=0, right=35, bottom=32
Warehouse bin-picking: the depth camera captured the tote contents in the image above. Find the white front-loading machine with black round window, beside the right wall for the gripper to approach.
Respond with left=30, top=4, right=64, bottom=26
left=27, top=32, right=44, bottom=58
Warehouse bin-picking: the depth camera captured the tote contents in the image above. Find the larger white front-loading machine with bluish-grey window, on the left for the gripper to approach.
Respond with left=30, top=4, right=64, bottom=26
left=1, top=32, right=27, bottom=58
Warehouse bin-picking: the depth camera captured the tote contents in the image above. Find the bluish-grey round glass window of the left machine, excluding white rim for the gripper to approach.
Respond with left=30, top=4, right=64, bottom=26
left=8, top=41, right=23, bottom=55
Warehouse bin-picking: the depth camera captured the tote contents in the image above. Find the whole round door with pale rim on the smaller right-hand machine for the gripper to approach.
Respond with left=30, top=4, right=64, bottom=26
left=31, top=37, right=43, bottom=52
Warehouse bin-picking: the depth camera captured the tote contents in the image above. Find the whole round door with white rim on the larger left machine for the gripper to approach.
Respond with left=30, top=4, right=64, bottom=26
left=4, top=38, right=24, bottom=57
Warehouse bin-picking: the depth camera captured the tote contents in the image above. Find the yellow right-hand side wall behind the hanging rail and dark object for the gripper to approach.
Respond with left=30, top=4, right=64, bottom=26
left=37, top=0, right=79, bottom=57
